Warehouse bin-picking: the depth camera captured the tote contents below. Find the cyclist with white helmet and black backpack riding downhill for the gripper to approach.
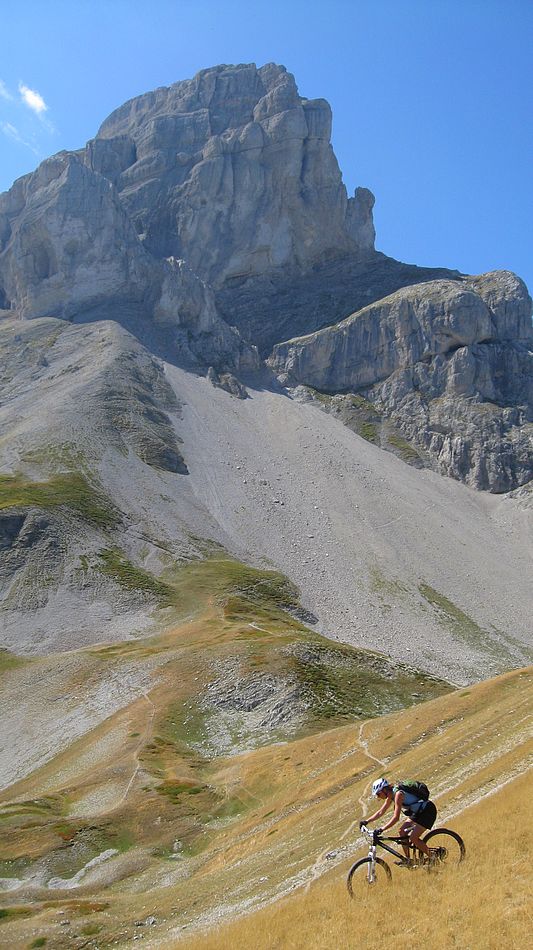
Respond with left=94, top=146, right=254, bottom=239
left=359, top=778, right=437, bottom=859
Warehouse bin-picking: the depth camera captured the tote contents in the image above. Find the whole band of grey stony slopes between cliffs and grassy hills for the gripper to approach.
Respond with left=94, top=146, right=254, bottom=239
left=0, top=320, right=533, bottom=683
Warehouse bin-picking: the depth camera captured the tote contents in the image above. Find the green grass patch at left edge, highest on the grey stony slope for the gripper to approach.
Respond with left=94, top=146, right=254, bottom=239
left=0, top=472, right=120, bottom=529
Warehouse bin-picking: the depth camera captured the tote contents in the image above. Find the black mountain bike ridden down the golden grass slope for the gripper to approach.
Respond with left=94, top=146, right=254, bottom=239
left=346, top=825, right=466, bottom=897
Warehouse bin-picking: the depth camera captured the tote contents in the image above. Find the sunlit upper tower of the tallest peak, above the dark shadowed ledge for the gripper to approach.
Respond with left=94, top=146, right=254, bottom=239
left=91, top=64, right=374, bottom=288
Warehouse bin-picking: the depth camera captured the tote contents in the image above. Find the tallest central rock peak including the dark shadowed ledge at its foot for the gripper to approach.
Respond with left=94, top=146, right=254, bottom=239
left=84, top=63, right=459, bottom=356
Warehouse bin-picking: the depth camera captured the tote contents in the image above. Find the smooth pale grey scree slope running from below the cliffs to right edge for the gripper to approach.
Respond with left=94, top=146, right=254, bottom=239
left=166, top=365, right=533, bottom=682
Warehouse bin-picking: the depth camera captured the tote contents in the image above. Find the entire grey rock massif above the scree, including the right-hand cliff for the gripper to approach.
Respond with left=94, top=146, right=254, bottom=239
left=0, top=64, right=533, bottom=492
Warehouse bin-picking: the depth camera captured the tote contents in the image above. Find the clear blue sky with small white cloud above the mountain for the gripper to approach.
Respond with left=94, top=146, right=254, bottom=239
left=0, top=0, right=533, bottom=291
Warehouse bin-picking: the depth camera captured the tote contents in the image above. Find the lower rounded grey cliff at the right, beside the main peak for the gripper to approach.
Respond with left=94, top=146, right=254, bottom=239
left=270, top=272, right=533, bottom=492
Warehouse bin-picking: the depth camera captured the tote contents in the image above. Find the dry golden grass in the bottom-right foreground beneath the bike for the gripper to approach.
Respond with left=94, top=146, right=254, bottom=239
left=172, top=774, right=533, bottom=950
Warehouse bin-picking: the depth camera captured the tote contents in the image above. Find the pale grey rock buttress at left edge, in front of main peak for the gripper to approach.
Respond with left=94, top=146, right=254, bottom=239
left=0, top=152, right=258, bottom=370
